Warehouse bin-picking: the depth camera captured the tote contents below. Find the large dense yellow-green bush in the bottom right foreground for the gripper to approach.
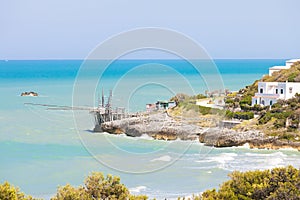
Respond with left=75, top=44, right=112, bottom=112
left=202, top=166, right=300, bottom=200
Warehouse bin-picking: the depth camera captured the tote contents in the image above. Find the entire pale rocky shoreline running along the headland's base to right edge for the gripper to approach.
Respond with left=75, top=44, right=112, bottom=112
left=101, top=113, right=300, bottom=151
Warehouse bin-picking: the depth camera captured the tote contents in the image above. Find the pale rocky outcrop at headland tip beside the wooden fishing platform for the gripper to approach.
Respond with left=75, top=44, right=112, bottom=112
left=101, top=113, right=203, bottom=140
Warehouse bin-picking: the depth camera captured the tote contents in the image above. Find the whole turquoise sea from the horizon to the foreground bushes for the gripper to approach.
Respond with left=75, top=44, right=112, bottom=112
left=0, top=60, right=300, bottom=199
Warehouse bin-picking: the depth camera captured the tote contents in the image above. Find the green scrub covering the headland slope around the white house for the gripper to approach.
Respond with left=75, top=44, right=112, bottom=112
left=171, top=62, right=300, bottom=139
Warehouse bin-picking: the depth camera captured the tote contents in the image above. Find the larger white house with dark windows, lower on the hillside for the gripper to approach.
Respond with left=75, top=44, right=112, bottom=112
left=252, top=82, right=300, bottom=106
